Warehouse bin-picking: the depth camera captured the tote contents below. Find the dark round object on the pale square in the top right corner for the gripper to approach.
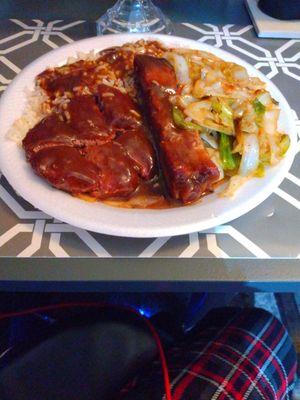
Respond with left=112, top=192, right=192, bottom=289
left=258, top=0, right=300, bottom=20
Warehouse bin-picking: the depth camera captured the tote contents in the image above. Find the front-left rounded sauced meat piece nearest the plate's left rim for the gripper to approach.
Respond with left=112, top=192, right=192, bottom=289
left=30, top=146, right=99, bottom=194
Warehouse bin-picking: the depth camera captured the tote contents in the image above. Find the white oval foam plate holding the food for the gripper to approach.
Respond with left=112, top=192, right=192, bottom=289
left=0, top=34, right=296, bottom=237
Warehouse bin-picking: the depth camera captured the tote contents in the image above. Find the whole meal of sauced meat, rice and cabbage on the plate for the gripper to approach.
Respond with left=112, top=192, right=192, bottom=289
left=9, top=40, right=289, bottom=208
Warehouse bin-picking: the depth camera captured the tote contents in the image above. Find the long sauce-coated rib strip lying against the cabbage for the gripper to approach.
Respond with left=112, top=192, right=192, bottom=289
left=134, top=55, right=219, bottom=204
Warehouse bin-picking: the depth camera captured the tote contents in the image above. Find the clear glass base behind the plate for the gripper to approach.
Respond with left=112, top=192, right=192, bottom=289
left=97, top=0, right=172, bottom=35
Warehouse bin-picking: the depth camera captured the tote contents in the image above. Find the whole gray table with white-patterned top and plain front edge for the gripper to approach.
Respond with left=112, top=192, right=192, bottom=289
left=0, top=18, right=300, bottom=291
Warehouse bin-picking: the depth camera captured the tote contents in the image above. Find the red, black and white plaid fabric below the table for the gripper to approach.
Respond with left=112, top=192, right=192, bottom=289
left=122, top=308, right=296, bottom=400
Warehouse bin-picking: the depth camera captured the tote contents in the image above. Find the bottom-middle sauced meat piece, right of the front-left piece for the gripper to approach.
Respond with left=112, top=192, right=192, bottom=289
left=84, top=142, right=139, bottom=199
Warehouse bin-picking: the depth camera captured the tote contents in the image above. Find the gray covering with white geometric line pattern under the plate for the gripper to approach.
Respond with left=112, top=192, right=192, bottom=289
left=0, top=19, right=300, bottom=258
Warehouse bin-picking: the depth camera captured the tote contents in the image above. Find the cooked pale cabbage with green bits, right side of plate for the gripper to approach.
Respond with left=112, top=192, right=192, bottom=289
left=166, top=49, right=290, bottom=195
